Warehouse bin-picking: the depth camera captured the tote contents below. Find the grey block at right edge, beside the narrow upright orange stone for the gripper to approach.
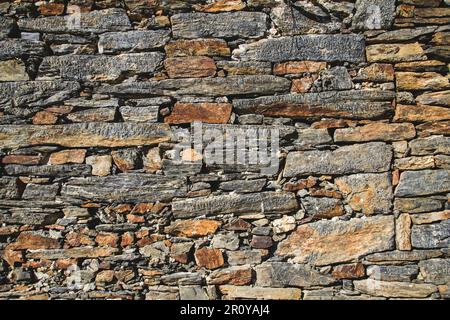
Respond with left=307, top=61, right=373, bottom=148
left=411, top=220, right=450, bottom=249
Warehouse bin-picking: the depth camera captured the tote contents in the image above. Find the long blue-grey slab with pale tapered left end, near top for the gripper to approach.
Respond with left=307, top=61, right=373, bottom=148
left=233, top=34, right=365, bottom=62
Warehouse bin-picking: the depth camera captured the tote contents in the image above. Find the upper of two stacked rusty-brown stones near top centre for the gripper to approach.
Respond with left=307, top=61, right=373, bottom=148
left=165, top=39, right=231, bottom=57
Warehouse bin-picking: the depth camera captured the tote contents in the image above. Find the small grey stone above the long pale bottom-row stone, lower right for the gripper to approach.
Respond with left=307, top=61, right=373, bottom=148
left=367, top=265, right=419, bottom=282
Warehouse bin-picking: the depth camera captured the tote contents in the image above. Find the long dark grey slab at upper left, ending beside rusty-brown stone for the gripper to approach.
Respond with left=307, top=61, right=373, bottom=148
left=38, top=52, right=164, bottom=81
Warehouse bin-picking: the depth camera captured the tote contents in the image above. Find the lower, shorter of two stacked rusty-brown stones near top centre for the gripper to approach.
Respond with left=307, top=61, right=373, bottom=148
left=164, top=56, right=216, bottom=78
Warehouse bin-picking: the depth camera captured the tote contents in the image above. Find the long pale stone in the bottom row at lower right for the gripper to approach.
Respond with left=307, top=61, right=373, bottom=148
left=353, top=279, right=437, bottom=298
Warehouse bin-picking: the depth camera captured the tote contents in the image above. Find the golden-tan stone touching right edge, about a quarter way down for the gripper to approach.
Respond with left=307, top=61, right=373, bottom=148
left=396, top=72, right=450, bottom=91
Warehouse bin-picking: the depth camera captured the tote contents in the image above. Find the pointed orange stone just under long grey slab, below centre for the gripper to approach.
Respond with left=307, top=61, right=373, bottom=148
left=164, top=219, right=221, bottom=238
